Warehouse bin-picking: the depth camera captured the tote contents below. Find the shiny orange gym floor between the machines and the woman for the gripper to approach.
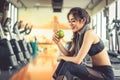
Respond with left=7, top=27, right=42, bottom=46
left=10, top=45, right=58, bottom=80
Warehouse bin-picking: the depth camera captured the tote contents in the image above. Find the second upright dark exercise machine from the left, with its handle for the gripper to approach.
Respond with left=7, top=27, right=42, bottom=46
left=3, top=18, right=24, bottom=63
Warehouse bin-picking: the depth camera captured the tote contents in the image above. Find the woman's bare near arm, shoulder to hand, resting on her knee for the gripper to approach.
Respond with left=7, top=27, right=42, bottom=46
left=58, top=30, right=96, bottom=64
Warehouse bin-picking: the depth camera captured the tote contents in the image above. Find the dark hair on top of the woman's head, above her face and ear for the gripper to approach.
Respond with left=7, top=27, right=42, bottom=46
left=67, top=7, right=90, bottom=24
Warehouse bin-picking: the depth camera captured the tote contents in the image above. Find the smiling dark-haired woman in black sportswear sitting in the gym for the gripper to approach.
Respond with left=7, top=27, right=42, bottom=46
left=53, top=7, right=114, bottom=80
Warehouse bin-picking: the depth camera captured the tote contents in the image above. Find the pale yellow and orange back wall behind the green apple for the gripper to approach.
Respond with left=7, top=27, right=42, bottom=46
left=18, top=8, right=72, bottom=42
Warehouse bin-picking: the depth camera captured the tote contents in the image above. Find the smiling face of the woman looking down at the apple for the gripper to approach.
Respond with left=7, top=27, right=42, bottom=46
left=69, top=14, right=85, bottom=32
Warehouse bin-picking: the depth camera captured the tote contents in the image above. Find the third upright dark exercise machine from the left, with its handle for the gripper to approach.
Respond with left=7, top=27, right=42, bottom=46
left=14, top=21, right=31, bottom=61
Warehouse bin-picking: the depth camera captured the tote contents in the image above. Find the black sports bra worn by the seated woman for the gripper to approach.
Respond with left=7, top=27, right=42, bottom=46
left=88, top=39, right=105, bottom=56
